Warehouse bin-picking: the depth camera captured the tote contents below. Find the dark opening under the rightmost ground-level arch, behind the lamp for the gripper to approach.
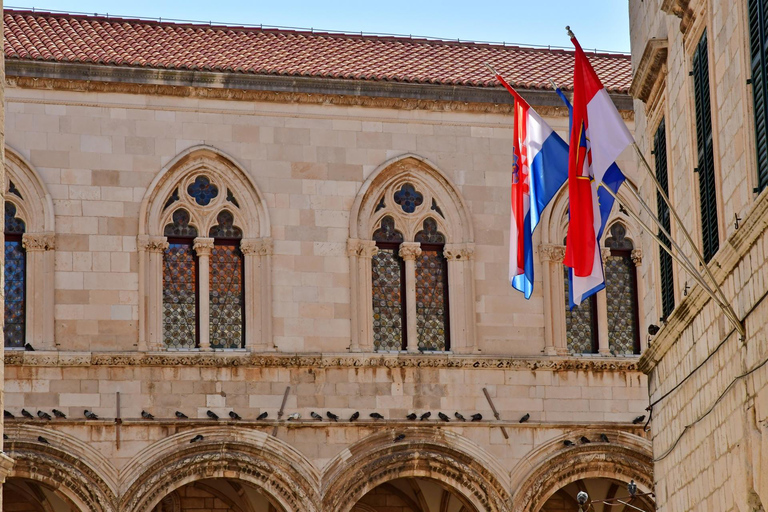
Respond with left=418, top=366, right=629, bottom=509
left=539, top=478, right=656, bottom=512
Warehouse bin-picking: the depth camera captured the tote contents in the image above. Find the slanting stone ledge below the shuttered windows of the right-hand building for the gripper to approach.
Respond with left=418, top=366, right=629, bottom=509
left=638, top=183, right=768, bottom=373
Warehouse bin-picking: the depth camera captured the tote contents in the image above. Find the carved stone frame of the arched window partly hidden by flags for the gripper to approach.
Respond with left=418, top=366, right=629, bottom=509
left=538, top=179, right=647, bottom=356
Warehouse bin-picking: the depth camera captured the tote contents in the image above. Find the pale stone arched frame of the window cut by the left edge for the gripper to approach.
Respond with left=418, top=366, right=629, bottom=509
left=3, top=146, right=57, bottom=350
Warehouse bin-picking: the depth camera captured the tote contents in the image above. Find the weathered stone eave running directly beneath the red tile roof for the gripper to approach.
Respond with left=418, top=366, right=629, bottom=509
left=5, top=59, right=632, bottom=114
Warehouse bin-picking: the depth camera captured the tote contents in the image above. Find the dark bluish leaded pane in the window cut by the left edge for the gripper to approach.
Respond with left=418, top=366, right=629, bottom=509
left=5, top=240, right=26, bottom=347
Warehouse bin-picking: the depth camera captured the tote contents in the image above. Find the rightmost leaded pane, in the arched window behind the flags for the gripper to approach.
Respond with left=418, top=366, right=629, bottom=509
left=605, top=254, right=639, bottom=355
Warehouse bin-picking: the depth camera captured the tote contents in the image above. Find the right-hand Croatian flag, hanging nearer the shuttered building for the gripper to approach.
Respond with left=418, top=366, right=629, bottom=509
left=564, top=37, right=634, bottom=307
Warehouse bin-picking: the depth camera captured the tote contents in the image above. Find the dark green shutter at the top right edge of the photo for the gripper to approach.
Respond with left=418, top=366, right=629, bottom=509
left=748, top=0, right=768, bottom=190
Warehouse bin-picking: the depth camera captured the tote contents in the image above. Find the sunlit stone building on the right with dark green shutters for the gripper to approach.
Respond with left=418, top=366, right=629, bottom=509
left=629, top=0, right=768, bottom=512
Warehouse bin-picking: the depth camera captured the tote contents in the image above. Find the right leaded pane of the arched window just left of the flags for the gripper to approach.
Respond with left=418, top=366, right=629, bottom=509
left=416, top=247, right=448, bottom=350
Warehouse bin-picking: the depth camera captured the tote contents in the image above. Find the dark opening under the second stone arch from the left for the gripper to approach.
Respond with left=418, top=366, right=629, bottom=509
left=152, top=478, right=284, bottom=512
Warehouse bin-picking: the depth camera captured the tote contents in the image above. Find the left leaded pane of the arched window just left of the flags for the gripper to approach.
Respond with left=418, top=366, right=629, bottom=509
left=371, top=247, right=405, bottom=350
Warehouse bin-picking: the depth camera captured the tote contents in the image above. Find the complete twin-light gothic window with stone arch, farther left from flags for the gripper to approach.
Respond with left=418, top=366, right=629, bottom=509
left=139, top=146, right=272, bottom=350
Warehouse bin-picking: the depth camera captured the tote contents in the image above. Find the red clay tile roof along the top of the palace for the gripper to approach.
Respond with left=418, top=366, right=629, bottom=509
left=4, top=10, right=632, bottom=93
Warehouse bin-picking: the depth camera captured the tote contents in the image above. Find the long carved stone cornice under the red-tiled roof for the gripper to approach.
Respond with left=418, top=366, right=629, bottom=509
left=6, top=60, right=634, bottom=120
